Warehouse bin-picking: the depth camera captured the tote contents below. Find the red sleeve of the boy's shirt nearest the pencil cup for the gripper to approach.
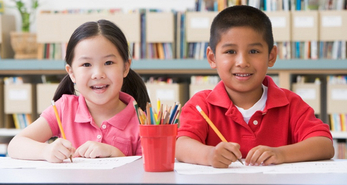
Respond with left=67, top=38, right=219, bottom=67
left=177, top=92, right=209, bottom=144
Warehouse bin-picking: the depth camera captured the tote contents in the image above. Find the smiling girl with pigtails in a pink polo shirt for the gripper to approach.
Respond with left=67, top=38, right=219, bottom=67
left=8, top=20, right=150, bottom=162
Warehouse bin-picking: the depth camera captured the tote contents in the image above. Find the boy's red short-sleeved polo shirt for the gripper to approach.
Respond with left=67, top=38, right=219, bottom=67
left=177, top=76, right=332, bottom=158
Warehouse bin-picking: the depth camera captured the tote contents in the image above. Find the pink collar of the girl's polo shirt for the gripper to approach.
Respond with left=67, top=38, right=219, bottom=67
left=75, top=92, right=135, bottom=130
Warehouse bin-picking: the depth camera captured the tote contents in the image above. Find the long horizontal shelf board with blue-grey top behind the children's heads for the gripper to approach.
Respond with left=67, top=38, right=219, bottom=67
left=0, top=59, right=347, bottom=75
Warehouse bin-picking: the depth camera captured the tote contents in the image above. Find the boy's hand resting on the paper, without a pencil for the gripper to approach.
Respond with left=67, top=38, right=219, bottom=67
left=245, top=145, right=284, bottom=166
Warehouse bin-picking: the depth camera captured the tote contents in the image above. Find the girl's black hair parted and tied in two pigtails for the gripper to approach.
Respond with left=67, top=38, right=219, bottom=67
left=53, top=19, right=150, bottom=110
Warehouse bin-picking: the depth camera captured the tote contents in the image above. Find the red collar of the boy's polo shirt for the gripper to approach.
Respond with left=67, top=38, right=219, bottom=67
left=206, top=76, right=289, bottom=111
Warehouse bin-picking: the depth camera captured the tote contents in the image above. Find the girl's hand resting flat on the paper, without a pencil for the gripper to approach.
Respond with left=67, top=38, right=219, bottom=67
left=73, top=141, right=125, bottom=158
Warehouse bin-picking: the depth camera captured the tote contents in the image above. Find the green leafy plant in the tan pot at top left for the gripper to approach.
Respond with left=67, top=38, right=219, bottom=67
left=12, top=0, right=39, bottom=32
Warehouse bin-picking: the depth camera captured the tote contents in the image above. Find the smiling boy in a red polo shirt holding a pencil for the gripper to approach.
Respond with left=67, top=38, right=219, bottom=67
left=176, top=6, right=334, bottom=168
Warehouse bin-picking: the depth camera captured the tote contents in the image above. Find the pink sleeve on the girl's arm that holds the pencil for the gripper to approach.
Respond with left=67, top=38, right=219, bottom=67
left=40, top=98, right=64, bottom=137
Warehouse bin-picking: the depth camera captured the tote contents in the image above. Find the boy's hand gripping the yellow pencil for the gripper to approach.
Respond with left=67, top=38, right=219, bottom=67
left=208, top=142, right=242, bottom=168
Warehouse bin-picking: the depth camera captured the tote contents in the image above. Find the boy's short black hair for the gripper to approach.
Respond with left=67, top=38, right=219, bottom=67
left=209, top=5, right=274, bottom=53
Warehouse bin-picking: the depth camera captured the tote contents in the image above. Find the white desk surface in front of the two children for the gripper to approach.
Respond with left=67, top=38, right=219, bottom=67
left=0, top=159, right=347, bottom=184
